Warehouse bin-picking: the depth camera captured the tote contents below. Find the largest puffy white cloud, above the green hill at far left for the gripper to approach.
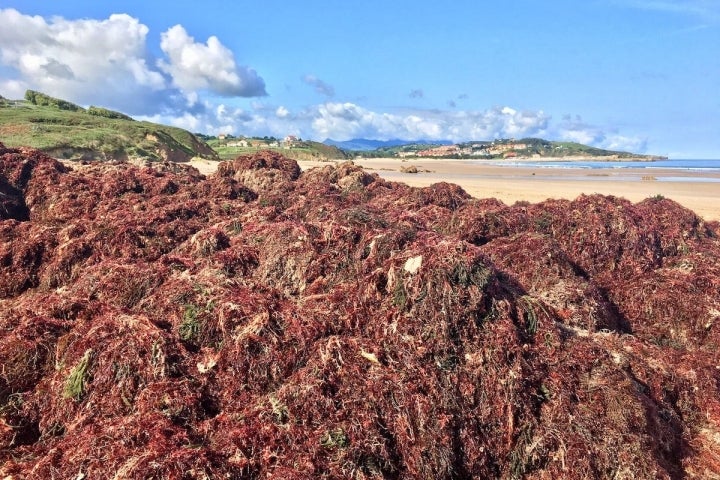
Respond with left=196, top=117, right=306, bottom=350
left=0, top=9, right=165, bottom=109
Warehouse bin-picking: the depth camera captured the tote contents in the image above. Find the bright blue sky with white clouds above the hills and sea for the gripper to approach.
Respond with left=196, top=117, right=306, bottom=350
left=0, top=0, right=720, bottom=158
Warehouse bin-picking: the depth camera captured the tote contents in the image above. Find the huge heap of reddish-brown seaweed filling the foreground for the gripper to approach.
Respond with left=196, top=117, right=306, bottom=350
left=0, top=144, right=720, bottom=479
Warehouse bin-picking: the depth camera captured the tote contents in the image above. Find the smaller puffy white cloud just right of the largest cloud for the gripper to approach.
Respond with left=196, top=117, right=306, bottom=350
left=158, top=25, right=266, bottom=97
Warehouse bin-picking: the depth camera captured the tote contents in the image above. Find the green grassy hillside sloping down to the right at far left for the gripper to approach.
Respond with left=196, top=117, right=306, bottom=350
left=0, top=91, right=217, bottom=161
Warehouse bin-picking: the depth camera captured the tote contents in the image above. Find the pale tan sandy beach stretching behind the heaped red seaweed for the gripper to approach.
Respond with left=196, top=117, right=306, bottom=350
left=193, top=158, right=720, bottom=220
